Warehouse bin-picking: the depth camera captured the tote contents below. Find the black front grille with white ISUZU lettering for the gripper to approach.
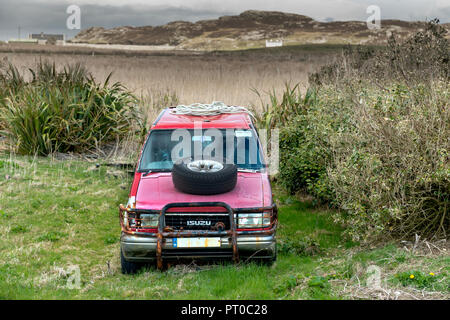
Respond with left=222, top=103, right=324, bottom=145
left=165, top=212, right=231, bottom=231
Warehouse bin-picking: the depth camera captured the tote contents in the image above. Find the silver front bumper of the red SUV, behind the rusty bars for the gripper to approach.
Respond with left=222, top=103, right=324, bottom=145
left=120, top=233, right=276, bottom=262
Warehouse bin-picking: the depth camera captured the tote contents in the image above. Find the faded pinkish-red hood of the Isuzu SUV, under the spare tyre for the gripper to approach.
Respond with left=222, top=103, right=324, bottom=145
left=136, top=172, right=271, bottom=210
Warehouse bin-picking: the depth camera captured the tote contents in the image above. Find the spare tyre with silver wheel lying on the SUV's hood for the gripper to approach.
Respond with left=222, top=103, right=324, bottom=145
left=172, top=160, right=237, bottom=195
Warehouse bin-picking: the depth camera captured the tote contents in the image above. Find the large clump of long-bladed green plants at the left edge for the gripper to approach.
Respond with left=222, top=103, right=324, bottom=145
left=0, top=63, right=138, bottom=155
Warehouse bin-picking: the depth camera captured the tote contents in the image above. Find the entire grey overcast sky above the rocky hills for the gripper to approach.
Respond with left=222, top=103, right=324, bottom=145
left=0, top=0, right=450, bottom=40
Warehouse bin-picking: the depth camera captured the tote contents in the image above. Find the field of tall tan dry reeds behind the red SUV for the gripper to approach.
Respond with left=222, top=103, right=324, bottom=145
left=0, top=46, right=334, bottom=110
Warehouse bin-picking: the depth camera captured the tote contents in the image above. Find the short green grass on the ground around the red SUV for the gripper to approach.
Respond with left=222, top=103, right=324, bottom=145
left=0, top=156, right=450, bottom=299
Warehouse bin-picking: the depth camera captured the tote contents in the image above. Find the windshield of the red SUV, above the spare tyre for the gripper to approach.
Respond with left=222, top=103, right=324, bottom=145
left=139, top=129, right=265, bottom=171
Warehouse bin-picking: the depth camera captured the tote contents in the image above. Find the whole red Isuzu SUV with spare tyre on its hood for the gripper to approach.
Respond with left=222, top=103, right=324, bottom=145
left=120, top=108, right=277, bottom=273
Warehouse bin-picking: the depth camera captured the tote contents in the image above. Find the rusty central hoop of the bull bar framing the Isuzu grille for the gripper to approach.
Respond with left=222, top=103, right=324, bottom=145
left=156, top=202, right=239, bottom=269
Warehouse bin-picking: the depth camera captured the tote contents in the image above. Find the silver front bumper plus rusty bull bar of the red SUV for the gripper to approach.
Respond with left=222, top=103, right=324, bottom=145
left=119, top=202, right=278, bottom=269
